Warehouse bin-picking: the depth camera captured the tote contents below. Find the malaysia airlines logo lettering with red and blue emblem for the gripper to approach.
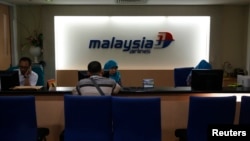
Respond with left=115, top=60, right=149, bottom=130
left=89, top=32, right=174, bottom=54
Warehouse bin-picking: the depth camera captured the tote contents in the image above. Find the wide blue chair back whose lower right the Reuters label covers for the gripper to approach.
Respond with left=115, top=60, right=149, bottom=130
left=187, top=96, right=236, bottom=141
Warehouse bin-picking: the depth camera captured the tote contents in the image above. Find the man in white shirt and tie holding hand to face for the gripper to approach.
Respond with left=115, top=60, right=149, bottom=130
left=18, top=57, right=38, bottom=86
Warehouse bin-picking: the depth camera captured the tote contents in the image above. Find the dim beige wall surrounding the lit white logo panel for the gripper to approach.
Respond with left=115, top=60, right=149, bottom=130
left=15, top=5, right=249, bottom=79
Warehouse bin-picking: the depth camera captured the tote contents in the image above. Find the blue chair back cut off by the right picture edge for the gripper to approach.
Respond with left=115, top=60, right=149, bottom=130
left=239, top=96, right=250, bottom=124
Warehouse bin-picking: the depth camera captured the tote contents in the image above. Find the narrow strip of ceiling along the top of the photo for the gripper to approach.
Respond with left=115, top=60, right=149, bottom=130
left=0, top=0, right=250, bottom=5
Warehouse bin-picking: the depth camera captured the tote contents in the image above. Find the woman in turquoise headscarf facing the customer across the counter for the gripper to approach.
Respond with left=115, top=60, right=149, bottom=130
left=103, top=60, right=121, bottom=86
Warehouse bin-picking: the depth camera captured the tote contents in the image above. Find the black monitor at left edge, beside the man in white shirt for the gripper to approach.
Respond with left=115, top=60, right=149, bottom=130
left=0, top=70, right=20, bottom=90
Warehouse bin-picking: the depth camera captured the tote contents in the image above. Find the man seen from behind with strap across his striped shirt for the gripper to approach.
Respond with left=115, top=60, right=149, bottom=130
left=73, top=61, right=121, bottom=96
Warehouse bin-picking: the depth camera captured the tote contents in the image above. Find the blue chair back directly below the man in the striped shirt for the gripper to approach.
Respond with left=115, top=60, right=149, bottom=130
left=64, top=95, right=112, bottom=141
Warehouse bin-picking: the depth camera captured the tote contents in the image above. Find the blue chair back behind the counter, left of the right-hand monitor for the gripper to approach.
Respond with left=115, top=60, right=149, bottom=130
left=174, top=67, right=193, bottom=87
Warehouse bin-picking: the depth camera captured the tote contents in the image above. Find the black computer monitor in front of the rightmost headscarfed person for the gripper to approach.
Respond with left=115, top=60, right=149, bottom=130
left=191, top=69, right=223, bottom=90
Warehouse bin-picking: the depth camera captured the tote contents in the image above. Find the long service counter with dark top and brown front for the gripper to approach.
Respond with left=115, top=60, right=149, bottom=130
left=0, top=87, right=250, bottom=141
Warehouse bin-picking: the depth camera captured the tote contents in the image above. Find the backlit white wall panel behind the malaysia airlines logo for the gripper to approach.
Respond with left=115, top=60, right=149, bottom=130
left=55, top=16, right=210, bottom=70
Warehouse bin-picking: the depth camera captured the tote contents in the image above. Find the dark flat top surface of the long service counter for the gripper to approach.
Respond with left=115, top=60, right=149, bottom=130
left=0, top=87, right=250, bottom=95
